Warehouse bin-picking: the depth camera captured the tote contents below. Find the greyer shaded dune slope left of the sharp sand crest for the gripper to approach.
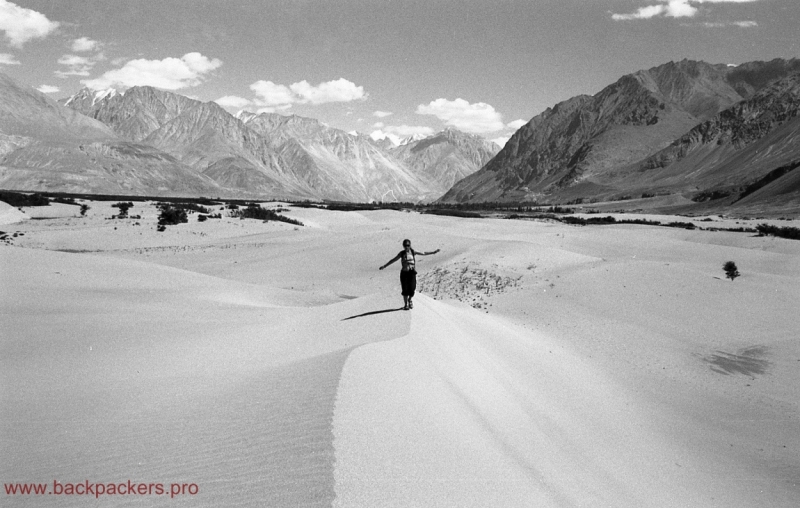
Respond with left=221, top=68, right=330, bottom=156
left=0, top=247, right=409, bottom=507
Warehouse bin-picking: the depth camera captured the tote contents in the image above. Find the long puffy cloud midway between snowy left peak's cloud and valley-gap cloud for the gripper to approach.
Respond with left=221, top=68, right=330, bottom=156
left=250, top=78, right=366, bottom=110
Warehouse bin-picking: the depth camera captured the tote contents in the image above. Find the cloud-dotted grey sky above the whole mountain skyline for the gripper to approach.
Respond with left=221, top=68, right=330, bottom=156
left=0, top=0, right=800, bottom=145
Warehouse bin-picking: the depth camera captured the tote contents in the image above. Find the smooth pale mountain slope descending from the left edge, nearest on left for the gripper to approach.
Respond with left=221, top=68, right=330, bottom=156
left=0, top=73, right=223, bottom=195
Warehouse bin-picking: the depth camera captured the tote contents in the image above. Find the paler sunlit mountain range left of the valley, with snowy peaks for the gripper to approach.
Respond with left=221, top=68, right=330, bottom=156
left=0, top=76, right=499, bottom=202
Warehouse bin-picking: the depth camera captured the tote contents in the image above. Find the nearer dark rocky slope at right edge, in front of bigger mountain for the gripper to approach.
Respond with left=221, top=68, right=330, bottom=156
left=610, top=73, right=800, bottom=210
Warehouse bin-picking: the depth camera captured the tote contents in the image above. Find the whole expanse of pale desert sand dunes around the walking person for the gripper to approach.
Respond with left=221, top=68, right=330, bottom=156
left=0, top=202, right=800, bottom=508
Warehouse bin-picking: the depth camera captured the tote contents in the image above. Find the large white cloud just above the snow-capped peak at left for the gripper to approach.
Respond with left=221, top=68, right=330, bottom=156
left=81, top=52, right=222, bottom=90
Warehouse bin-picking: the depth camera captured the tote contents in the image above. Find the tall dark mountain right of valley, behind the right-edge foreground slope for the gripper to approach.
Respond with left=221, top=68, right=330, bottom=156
left=441, top=60, right=800, bottom=202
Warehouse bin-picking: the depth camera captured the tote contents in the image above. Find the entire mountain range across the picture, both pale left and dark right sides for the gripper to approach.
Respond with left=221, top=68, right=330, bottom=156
left=0, top=59, right=800, bottom=209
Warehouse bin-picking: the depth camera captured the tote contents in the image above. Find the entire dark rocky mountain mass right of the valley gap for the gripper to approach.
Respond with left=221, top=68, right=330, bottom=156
left=441, top=59, right=800, bottom=213
